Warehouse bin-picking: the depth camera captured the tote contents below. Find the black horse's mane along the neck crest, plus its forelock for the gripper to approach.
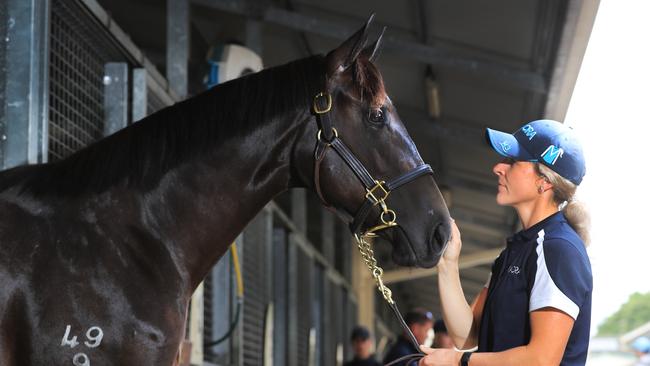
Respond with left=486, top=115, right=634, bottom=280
left=0, top=56, right=385, bottom=196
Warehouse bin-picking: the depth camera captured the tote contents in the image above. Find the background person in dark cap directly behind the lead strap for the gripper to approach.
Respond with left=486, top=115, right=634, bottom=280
left=384, top=308, right=433, bottom=366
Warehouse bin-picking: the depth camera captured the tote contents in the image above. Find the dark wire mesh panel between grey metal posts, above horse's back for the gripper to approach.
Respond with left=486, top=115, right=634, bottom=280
left=48, top=0, right=132, bottom=161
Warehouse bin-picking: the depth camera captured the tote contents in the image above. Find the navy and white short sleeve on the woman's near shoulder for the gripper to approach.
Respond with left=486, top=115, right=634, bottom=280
left=529, top=231, right=592, bottom=320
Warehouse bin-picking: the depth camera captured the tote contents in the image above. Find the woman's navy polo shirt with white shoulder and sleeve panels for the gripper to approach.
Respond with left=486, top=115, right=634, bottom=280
left=478, top=212, right=593, bottom=366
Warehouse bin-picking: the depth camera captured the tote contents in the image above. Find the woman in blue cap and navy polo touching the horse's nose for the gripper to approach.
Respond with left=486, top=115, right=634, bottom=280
left=420, top=120, right=592, bottom=366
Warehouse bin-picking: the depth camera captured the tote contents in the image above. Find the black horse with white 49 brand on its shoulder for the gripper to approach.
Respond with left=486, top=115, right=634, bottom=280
left=0, top=17, right=449, bottom=366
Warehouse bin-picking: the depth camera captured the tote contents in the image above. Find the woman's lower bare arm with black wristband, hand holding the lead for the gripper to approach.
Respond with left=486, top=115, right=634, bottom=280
left=420, top=308, right=574, bottom=366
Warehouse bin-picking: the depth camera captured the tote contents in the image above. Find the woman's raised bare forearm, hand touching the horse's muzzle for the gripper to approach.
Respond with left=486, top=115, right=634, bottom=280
left=438, top=222, right=487, bottom=349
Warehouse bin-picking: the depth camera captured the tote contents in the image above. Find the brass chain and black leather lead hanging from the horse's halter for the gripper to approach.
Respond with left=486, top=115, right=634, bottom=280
left=354, top=233, right=425, bottom=366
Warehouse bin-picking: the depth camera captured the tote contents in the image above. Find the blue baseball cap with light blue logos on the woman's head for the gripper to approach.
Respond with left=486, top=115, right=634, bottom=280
left=485, top=119, right=586, bottom=185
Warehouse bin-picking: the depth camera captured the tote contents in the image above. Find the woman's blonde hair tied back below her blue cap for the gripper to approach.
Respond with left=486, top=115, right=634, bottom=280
left=535, top=163, right=591, bottom=246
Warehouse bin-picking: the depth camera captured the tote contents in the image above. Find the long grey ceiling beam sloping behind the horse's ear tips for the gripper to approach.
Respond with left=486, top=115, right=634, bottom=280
left=192, top=0, right=547, bottom=93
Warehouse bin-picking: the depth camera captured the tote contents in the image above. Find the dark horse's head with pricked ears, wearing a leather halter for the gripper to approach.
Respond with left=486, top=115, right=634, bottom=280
left=296, top=17, right=451, bottom=267
